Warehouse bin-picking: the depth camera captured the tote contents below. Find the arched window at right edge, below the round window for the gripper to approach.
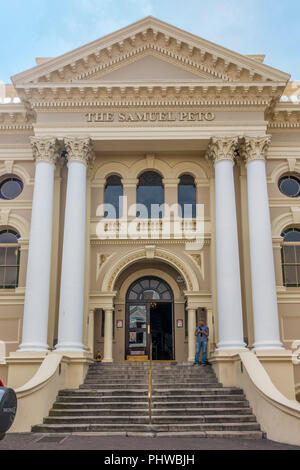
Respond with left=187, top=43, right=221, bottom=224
left=281, top=228, right=300, bottom=287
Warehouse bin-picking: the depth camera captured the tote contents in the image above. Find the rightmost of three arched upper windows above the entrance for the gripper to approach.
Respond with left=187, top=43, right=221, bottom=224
left=178, top=175, right=196, bottom=218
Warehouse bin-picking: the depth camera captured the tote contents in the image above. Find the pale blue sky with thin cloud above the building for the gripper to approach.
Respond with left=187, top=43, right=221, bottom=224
left=0, top=0, right=300, bottom=83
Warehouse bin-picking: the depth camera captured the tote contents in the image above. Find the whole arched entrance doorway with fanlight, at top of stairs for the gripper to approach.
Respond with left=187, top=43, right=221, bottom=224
left=125, top=277, right=174, bottom=361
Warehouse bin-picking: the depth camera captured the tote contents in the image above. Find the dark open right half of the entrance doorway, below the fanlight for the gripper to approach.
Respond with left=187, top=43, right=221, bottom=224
left=150, top=303, right=173, bottom=361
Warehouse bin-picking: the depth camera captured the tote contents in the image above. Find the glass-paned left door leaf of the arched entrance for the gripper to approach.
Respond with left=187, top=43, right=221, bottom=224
left=126, top=303, right=149, bottom=357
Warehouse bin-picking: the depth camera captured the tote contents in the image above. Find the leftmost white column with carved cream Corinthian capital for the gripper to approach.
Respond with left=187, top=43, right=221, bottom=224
left=19, top=137, right=59, bottom=352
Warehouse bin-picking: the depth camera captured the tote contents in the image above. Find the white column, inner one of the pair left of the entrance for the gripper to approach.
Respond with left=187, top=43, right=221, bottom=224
left=56, top=138, right=93, bottom=351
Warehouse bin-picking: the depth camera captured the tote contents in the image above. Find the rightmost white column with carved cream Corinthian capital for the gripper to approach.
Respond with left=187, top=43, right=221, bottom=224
left=243, top=136, right=283, bottom=350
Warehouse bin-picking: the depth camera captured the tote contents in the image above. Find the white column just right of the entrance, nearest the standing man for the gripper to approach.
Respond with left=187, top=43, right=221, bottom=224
left=207, top=137, right=245, bottom=351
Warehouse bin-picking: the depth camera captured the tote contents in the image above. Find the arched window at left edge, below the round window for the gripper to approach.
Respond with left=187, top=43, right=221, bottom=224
left=0, top=228, right=20, bottom=289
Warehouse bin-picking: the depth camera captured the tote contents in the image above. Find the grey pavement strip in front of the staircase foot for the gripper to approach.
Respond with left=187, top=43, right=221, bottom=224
left=0, top=433, right=300, bottom=452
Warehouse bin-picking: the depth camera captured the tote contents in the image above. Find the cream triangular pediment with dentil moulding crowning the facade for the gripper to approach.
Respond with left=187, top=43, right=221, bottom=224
left=12, top=17, right=289, bottom=87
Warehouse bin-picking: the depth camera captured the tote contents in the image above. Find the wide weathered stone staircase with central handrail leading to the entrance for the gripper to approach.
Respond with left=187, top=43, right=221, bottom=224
left=32, top=363, right=263, bottom=439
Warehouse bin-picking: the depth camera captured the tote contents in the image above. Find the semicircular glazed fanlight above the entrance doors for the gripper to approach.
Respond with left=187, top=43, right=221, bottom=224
left=127, top=277, right=173, bottom=302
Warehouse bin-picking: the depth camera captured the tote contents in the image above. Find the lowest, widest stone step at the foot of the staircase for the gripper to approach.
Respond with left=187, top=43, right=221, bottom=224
left=33, top=423, right=260, bottom=433
